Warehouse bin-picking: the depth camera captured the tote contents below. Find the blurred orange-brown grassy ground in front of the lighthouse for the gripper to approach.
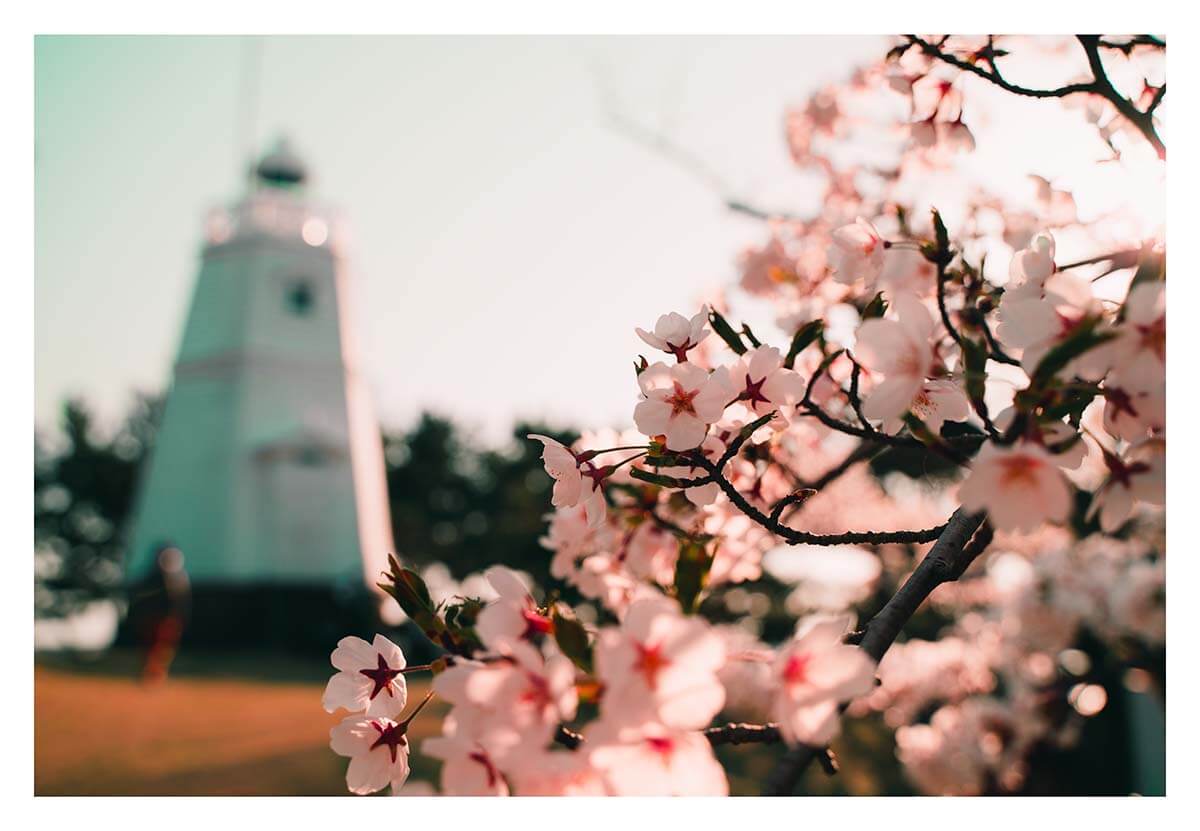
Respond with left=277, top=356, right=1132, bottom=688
left=34, top=652, right=442, bottom=795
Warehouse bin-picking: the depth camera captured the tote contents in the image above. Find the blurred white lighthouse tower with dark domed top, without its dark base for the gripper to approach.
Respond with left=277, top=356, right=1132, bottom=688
left=128, top=136, right=391, bottom=629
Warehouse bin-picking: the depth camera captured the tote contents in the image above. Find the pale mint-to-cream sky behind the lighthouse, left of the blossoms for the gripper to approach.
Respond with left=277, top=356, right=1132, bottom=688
left=35, top=37, right=886, bottom=440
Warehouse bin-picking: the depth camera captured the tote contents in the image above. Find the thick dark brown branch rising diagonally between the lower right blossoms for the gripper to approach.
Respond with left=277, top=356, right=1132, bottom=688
left=763, top=508, right=992, bottom=796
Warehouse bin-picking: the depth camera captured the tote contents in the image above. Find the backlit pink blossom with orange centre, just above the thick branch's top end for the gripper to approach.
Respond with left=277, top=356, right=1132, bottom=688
left=959, top=442, right=1072, bottom=531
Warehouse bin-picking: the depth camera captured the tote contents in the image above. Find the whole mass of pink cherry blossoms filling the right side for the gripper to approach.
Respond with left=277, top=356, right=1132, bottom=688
left=325, top=36, right=1166, bottom=795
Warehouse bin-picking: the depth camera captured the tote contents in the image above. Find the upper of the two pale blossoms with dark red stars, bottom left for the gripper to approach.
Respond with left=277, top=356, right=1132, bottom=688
left=322, top=634, right=408, bottom=718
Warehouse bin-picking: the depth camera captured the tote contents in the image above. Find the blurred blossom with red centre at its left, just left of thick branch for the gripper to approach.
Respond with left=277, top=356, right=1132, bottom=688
left=773, top=617, right=875, bottom=745
